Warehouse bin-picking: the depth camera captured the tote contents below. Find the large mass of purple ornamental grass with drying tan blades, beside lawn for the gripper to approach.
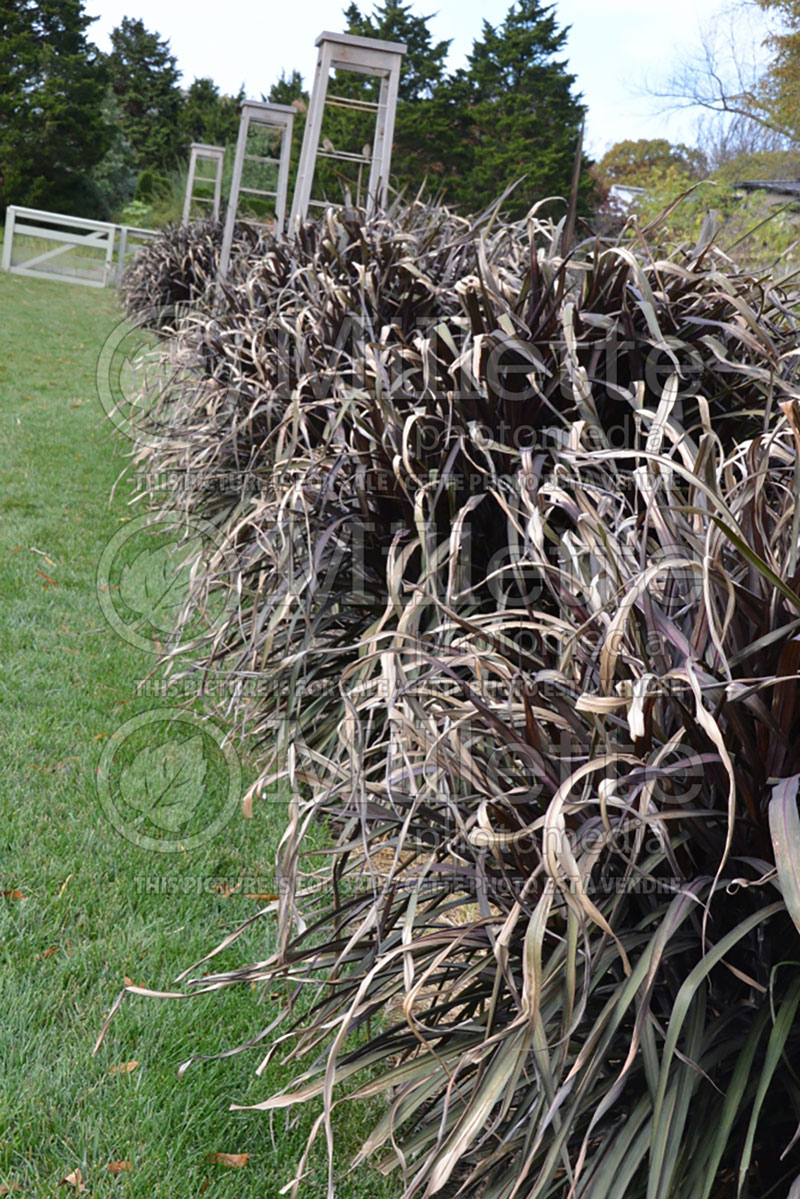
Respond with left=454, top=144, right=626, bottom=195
left=120, top=206, right=800, bottom=1199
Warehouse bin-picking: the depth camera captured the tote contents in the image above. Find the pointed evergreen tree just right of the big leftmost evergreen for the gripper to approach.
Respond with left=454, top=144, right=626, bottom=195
left=108, top=17, right=187, bottom=171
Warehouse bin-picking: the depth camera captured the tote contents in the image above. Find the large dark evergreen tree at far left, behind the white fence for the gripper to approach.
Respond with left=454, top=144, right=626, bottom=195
left=0, top=0, right=112, bottom=216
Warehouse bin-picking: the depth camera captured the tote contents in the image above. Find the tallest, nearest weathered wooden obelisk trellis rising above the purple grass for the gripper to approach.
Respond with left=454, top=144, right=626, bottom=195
left=291, top=32, right=407, bottom=224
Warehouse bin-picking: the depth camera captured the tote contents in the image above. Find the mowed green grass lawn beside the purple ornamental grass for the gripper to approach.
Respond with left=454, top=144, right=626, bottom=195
left=0, top=275, right=398, bottom=1199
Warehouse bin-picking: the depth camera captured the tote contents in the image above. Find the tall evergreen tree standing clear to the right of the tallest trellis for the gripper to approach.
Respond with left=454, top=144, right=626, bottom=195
left=447, top=0, right=593, bottom=216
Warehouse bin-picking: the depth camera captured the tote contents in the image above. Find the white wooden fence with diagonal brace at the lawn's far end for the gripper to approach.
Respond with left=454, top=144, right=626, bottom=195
left=2, top=205, right=156, bottom=288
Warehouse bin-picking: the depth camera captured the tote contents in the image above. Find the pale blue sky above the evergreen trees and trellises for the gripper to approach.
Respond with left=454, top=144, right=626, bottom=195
left=86, top=0, right=762, bottom=156
